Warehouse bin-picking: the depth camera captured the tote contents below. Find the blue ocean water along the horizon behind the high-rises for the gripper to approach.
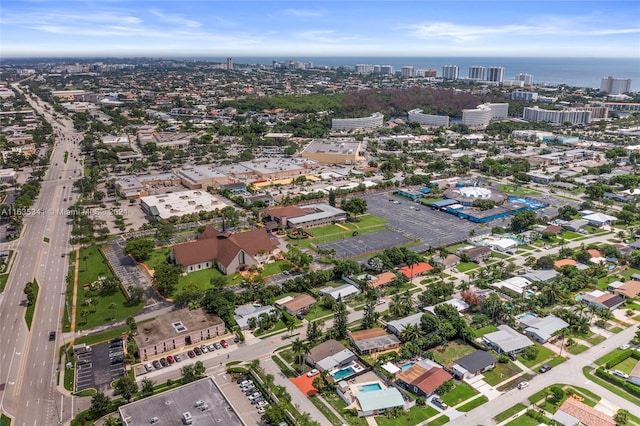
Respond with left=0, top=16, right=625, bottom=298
left=207, top=57, right=640, bottom=91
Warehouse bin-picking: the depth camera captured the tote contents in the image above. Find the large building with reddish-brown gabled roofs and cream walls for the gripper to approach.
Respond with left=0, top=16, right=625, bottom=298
left=171, top=227, right=278, bottom=275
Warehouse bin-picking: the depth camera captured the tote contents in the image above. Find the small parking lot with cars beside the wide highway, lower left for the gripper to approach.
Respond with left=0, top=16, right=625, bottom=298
left=76, top=338, right=125, bottom=392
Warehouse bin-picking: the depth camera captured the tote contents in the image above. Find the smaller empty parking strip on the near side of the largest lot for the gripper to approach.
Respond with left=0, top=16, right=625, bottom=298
left=318, top=230, right=411, bottom=259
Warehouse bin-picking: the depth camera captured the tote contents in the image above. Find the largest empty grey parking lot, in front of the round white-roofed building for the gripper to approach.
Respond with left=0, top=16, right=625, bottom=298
left=363, top=192, right=489, bottom=247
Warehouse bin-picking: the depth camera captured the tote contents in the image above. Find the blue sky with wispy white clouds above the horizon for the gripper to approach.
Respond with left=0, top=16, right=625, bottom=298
left=0, top=0, right=640, bottom=58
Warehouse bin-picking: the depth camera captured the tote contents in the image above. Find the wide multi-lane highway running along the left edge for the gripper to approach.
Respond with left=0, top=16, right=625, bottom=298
left=0, top=84, right=82, bottom=426
